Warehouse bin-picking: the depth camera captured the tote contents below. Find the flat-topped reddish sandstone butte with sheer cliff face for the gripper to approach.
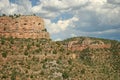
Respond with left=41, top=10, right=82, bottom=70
left=0, top=16, right=50, bottom=39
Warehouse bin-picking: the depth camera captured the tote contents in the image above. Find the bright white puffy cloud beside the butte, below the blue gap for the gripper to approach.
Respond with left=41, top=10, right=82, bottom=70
left=45, top=17, right=79, bottom=34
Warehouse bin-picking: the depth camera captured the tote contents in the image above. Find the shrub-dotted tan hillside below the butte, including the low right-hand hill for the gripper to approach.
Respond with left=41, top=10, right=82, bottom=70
left=0, top=37, right=120, bottom=80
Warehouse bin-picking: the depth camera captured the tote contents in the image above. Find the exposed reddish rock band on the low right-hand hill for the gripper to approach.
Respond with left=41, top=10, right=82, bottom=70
left=67, top=38, right=111, bottom=51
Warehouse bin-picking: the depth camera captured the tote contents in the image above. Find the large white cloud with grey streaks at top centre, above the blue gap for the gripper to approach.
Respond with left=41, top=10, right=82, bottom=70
left=32, top=0, right=88, bottom=19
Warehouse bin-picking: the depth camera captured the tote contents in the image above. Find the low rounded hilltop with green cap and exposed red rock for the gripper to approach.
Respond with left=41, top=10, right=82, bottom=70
left=64, top=37, right=112, bottom=51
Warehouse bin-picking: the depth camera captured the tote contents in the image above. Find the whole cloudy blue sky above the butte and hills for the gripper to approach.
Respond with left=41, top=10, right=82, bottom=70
left=0, top=0, right=120, bottom=41
